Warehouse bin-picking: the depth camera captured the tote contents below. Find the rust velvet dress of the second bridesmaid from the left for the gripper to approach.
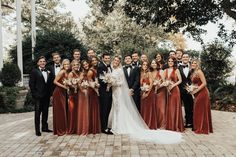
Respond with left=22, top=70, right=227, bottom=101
left=67, top=72, right=79, bottom=134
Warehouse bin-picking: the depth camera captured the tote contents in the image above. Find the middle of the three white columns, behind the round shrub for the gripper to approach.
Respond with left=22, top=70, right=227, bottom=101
left=16, top=0, right=23, bottom=86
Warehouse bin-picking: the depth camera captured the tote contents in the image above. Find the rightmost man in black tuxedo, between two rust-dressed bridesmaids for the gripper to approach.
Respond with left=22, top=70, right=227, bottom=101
left=179, top=53, right=193, bottom=128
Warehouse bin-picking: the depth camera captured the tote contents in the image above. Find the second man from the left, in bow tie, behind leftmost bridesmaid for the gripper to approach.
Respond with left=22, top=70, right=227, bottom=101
left=49, top=52, right=61, bottom=92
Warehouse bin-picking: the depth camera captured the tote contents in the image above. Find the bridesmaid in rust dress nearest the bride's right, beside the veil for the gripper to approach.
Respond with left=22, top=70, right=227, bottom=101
left=140, top=61, right=157, bottom=129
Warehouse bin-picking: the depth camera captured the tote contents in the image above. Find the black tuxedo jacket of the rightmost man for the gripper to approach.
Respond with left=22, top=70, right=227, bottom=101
left=178, top=65, right=191, bottom=93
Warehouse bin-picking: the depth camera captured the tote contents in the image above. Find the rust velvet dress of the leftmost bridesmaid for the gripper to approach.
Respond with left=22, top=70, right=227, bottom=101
left=53, top=74, right=68, bottom=136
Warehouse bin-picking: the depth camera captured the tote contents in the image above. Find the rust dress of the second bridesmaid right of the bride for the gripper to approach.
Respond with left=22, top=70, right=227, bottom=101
left=155, top=70, right=166, bottom=129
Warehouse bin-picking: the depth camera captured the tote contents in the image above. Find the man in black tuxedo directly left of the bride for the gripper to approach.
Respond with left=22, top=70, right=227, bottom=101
left=97, top=53, right=112, bottom=134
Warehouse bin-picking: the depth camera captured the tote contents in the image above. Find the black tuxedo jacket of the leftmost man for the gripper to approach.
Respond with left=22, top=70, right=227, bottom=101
left=29, top=68, right=53, bottom=99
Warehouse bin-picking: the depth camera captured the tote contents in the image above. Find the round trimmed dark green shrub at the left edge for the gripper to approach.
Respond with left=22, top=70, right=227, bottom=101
left=0, top=63, right=21, bottom=87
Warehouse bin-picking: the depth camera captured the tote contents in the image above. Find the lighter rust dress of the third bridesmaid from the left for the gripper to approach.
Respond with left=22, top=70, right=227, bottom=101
left=76, top=76, right=89, bottom=135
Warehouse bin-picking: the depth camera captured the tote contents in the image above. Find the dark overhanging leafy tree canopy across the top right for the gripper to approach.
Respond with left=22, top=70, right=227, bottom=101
left=90, top=0, right=236, bottom=45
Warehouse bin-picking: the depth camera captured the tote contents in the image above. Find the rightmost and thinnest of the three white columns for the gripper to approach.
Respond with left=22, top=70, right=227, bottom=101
left=31, top=0, right=36, bottom=60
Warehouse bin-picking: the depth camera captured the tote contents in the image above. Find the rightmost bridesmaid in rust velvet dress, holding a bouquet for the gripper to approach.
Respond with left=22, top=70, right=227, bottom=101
left=191, top=60, right=213, bottom=134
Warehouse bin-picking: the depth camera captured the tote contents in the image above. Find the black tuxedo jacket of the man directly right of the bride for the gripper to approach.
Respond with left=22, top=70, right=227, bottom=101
left=123, top=66, right=140, bottom=92
